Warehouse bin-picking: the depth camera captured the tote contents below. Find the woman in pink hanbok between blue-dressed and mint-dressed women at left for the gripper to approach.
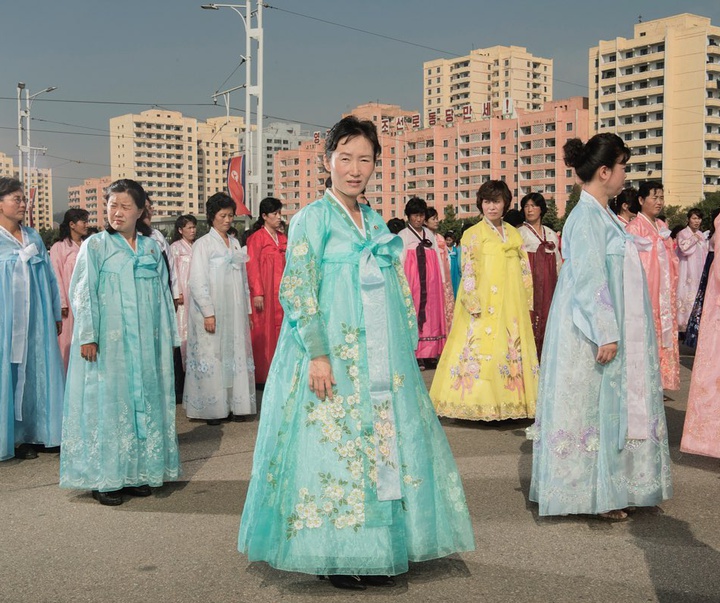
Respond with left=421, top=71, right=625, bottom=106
left=50, top=209, right=90, bottom=373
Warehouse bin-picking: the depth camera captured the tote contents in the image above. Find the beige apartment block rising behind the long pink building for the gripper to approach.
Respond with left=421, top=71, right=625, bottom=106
left=423, top=46, right=553, bottom=127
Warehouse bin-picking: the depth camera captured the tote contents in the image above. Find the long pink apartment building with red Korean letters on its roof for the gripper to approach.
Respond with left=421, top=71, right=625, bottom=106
left=275, top=97, right=588, bottom=220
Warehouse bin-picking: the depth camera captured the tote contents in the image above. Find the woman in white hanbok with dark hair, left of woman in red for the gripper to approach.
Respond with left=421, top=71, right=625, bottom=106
left=183, top=193, right=255, bottom=425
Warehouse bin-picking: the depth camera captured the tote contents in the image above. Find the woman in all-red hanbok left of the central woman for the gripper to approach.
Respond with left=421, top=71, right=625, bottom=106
left=247, top=197, right=287, bottom=385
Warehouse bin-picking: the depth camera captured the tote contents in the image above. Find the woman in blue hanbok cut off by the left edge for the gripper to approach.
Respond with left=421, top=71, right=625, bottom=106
left=0, top=178, right=64, bottom=461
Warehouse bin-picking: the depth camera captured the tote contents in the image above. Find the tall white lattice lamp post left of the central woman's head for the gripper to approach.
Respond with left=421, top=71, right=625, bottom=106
left=201, top=0, right=266, bottom=213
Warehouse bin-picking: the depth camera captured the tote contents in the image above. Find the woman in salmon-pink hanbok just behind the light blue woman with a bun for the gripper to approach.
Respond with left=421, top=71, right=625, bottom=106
left=625, top=182, right=680, bottom=390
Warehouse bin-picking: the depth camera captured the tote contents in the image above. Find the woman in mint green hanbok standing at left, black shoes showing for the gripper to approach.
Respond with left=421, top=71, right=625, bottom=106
left=60, top=180, right=180, bottom=505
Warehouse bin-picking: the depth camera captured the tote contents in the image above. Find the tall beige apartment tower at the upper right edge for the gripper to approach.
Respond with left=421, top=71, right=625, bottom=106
left=589, top=14, right=720, bottom=205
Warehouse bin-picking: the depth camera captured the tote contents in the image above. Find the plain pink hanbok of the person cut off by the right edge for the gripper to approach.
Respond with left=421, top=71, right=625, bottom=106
left=680, top=215, right=720, bottom=458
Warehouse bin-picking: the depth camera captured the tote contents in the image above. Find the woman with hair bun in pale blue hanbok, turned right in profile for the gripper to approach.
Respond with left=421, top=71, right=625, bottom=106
left=528, top=133, right=672, bottom=520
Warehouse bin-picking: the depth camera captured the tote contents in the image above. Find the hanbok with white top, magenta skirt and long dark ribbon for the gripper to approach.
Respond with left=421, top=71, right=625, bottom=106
left=398, top=226, right=447, bottom=359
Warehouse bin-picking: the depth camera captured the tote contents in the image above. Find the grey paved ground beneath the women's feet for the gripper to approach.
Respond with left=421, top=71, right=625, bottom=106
left=0, top=357, right=720, bottom=603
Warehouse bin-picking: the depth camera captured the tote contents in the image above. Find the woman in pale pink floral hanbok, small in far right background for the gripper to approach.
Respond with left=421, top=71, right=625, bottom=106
left=677, top=208, right=708, bottom=333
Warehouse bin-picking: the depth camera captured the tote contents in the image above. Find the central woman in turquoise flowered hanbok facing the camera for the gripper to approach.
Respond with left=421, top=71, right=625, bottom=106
left=238, top=116, right=474, bottom=589
